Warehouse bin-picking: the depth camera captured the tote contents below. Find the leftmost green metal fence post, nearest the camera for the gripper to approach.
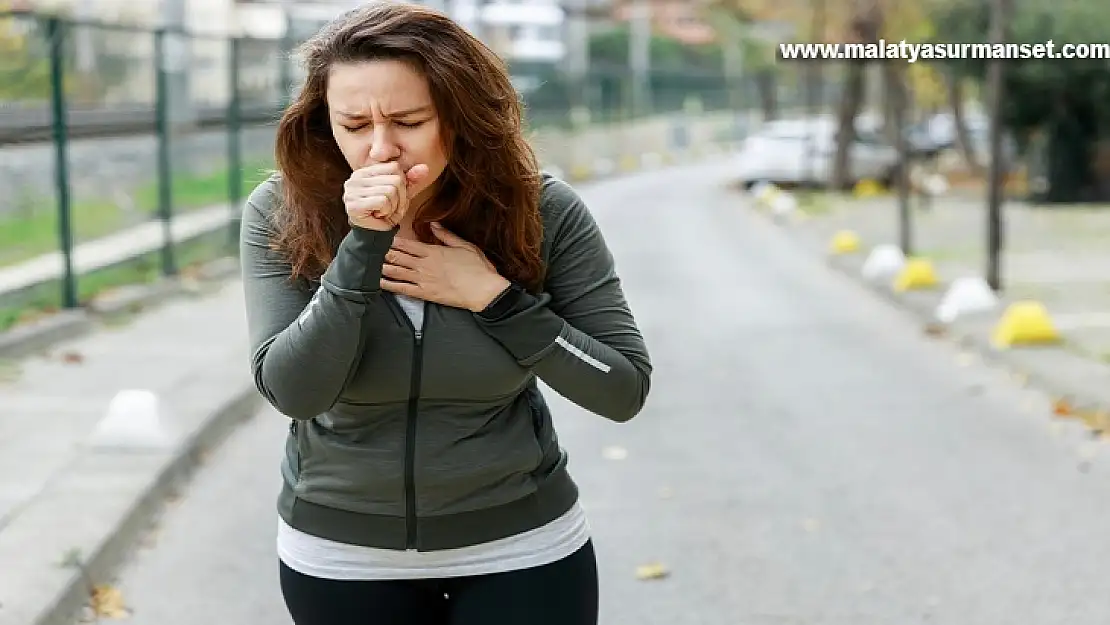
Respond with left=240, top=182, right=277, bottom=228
left=47, top=16, right=79, bottom=309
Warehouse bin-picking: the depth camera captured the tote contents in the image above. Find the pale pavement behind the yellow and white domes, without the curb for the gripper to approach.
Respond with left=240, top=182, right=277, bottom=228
left=777, top=192, right=1110, bottom=360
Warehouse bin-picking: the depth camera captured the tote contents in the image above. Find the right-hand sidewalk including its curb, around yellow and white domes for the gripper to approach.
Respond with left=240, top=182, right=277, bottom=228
left=737, top=184, right=1110, bottom=426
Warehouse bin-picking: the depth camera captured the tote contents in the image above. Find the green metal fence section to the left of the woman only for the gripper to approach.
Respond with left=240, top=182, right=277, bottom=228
left=0, top=13, right=294, bottom=330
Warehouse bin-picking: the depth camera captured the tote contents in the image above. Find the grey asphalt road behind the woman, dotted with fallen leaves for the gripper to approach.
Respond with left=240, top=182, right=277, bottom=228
left=97, top=165, right=1110, bottom=625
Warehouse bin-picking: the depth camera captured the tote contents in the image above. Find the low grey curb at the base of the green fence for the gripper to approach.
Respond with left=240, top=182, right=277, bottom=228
left=0, top=256, right=239, bottom=360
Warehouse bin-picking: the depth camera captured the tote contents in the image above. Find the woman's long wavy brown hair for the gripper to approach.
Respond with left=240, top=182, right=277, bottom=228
left=274, top=1, right=544, bottom=291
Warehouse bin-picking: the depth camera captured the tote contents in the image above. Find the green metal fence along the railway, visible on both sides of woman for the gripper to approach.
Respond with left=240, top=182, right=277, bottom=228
left=0, top=12, right=757, bottom=331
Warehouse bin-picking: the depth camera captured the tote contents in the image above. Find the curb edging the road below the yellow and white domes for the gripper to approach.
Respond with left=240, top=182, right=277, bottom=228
left=744, top=195, right=1110, bottom=424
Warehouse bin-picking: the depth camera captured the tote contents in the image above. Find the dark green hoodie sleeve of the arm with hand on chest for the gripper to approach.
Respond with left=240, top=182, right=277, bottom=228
left=475, top=173, right=652, bottom=422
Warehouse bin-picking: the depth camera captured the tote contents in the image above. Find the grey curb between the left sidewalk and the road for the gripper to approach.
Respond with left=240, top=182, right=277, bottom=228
left=16, top=382, right=262, bottom=625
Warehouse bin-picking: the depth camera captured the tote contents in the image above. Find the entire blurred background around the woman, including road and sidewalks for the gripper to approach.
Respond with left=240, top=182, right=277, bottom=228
left=0, top=0, right=1110, bottom=625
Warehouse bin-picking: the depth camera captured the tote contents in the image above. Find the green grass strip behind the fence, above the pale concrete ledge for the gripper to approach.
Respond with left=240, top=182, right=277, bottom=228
left=0, top=160, right=273, bottom=266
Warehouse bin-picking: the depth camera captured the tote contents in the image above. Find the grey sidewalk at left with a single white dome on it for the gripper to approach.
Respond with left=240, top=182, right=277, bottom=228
left=0, top=282, right=258, bottom=625
